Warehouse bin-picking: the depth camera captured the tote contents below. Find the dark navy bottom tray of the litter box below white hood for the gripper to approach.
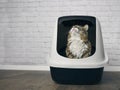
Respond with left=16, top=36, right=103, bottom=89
left=50, top=67, right=104, bottom=85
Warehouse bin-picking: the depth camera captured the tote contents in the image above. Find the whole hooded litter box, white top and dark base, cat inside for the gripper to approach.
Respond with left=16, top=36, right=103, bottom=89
left=48, top=16, right=108, bottom=85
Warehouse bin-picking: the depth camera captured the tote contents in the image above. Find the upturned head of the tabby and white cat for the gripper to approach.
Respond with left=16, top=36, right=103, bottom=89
left=70, top=24, right=89, bottom=41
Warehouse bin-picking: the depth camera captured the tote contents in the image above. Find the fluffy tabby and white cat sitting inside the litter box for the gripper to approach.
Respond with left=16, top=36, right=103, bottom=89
left=66, top=24, right=91, bottom=59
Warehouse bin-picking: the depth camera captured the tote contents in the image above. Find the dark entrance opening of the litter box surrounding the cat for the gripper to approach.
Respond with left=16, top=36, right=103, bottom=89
left=57, top=16, right=96, bottom=57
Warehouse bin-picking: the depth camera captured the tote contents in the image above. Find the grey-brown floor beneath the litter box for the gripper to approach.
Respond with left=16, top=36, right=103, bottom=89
left=0, top=70, right=120, bottom=90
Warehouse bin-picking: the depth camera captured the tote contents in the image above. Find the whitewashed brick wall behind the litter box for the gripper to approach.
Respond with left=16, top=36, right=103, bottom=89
left=0, top=0, right=120, bottom=65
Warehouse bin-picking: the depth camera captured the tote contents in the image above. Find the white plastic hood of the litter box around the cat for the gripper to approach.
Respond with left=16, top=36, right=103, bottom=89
left=48, top=18, right=108, bottom=68
